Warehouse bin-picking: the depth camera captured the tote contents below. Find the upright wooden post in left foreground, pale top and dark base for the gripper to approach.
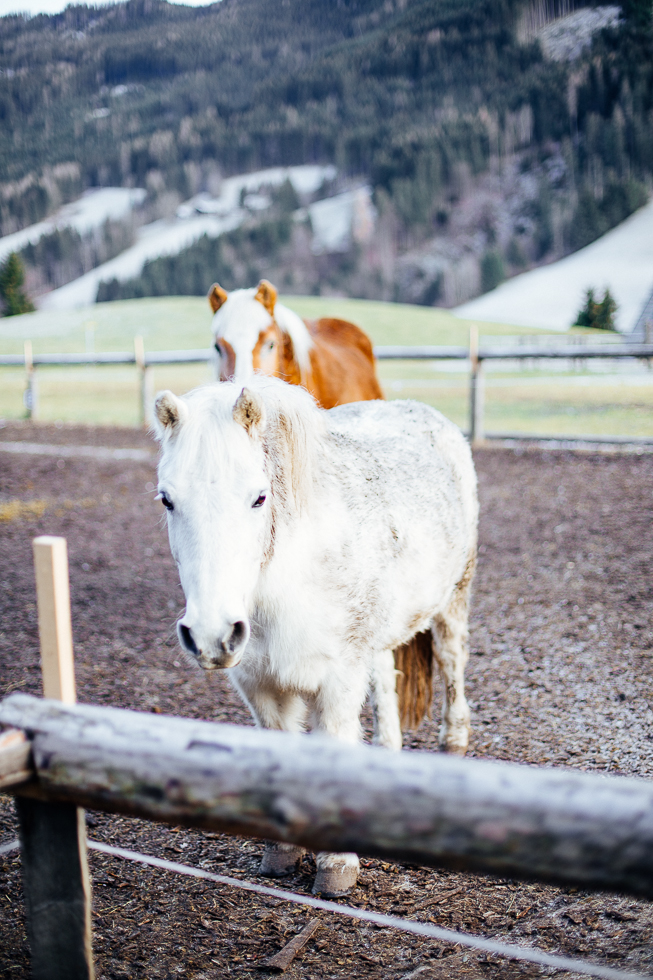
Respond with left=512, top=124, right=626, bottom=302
left=16, top=537, right=94, bottom=980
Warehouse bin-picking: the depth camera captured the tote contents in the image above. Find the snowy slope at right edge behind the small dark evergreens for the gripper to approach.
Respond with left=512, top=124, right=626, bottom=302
left=452, top=201, right=653, bottom=333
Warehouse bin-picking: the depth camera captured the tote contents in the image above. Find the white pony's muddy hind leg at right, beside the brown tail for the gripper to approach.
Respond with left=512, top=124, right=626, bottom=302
left=432, top=557, right=474, bottom=755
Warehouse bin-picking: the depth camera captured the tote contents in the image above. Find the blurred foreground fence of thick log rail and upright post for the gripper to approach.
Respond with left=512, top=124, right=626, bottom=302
left=0, top=538, right=653, bottom=980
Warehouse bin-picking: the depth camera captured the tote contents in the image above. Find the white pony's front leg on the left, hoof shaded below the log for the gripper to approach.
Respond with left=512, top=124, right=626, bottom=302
left=232, top=678, right=307, bottom=878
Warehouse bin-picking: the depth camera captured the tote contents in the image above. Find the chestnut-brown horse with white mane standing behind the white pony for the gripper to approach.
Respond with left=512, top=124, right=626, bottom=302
left=208, top=279, right=383, bottom=408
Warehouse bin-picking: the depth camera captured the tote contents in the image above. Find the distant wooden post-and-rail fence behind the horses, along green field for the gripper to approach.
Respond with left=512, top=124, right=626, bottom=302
left=0, top=336, right=653, bottom=445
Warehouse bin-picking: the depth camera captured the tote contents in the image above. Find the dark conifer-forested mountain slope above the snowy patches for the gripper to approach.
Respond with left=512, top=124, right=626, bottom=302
left=0, top=0, right=653, bottom=302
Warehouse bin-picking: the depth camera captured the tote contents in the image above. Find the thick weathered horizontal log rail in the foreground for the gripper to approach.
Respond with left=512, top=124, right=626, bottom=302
left=0, top=694, right=653, bottom=898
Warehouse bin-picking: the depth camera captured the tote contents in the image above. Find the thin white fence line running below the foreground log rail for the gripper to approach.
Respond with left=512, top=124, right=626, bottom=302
left=0, top=840, right=653, bottom=980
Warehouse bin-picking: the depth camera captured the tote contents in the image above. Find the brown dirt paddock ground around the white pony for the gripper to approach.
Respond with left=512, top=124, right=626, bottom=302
left=0, top=423, right=653, bottom=980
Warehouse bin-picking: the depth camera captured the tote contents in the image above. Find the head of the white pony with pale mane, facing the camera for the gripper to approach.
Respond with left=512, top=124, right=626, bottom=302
left=154, top=378, right=320, bottom=670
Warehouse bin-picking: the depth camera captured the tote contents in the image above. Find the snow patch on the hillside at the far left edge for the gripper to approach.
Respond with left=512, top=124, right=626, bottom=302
left=0, top=187, right=147, bottom=262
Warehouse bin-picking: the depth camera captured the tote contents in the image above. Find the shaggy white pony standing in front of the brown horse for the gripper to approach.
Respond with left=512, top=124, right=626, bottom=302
left=155, top=376, right=478, bottom=895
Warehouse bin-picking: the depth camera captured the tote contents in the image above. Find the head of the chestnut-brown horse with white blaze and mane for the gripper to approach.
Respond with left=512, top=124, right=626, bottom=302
left=208, top=279, right=312, bottom=384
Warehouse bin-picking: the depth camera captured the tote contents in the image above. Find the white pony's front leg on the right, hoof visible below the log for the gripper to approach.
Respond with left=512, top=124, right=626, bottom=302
left=313, top=666, right=367, bottom=898
